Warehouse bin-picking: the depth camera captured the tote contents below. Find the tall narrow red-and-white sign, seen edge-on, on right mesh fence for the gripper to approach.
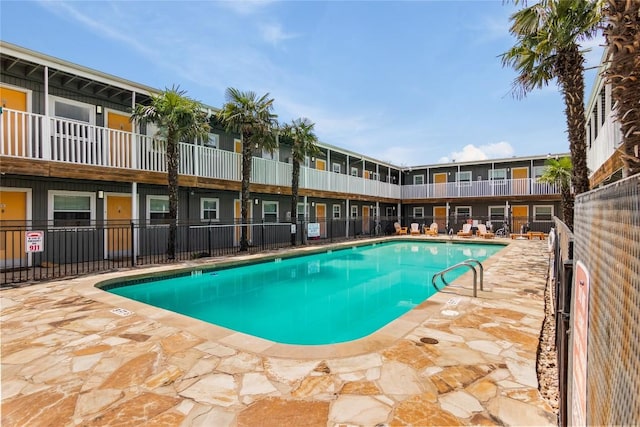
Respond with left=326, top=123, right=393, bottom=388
left=571, top=261, right=590, bottom=426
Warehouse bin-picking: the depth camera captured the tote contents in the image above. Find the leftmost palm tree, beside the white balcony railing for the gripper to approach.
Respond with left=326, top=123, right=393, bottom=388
left=130, top=85, right=209, bottom=259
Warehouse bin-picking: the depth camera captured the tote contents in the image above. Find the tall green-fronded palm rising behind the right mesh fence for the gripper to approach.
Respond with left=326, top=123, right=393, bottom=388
left=501, top=0, right=601, bottom=231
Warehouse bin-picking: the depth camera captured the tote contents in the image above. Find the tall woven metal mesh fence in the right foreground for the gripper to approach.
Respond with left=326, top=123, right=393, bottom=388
left=552, top=175, right=640, bottom=426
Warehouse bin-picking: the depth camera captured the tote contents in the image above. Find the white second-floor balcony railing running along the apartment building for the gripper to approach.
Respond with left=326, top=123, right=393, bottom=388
left=0, top=109, right=558, bottom=200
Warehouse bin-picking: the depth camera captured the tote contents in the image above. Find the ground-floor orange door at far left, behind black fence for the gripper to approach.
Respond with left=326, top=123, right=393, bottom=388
left=0, top=191, right=27, bottom=268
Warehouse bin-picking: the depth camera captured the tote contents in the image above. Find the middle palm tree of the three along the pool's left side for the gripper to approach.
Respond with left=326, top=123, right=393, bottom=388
left=216, top=88, right=278, bottom=251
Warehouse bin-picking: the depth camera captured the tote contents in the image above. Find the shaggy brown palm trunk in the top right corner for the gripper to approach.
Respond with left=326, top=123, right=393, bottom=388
left=603, top=0, right=640, bottom=176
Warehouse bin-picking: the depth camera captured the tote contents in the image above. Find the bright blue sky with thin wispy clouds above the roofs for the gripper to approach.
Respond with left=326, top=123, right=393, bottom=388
left=0, top=0, right=603, bottom=166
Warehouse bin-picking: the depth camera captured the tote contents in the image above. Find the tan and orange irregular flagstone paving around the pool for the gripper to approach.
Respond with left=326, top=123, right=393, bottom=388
left=0, top=240, right=557, bottom=427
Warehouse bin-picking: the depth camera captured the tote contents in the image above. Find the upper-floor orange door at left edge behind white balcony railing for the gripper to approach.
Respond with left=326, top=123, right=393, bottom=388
left=0, top=87, right=27, bottom=156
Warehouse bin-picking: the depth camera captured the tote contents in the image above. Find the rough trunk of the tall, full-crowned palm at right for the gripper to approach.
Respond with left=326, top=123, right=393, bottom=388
left=555, top=43, right=589, bottom=229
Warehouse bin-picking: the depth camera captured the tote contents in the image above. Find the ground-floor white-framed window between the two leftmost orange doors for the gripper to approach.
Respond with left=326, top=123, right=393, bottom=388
left=49, top=191, right=96, bottom=227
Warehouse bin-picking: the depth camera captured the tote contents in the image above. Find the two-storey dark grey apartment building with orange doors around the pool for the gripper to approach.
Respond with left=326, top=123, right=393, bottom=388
left=0, top=42, right=567, bottom=268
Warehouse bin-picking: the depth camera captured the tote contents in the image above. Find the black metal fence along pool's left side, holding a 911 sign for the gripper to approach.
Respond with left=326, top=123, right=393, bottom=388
left=0, top=218, right=394, bottom=286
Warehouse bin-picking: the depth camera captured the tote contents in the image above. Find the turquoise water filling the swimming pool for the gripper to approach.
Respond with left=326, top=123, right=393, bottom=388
left=107, top=241, right=503, bottom=345
